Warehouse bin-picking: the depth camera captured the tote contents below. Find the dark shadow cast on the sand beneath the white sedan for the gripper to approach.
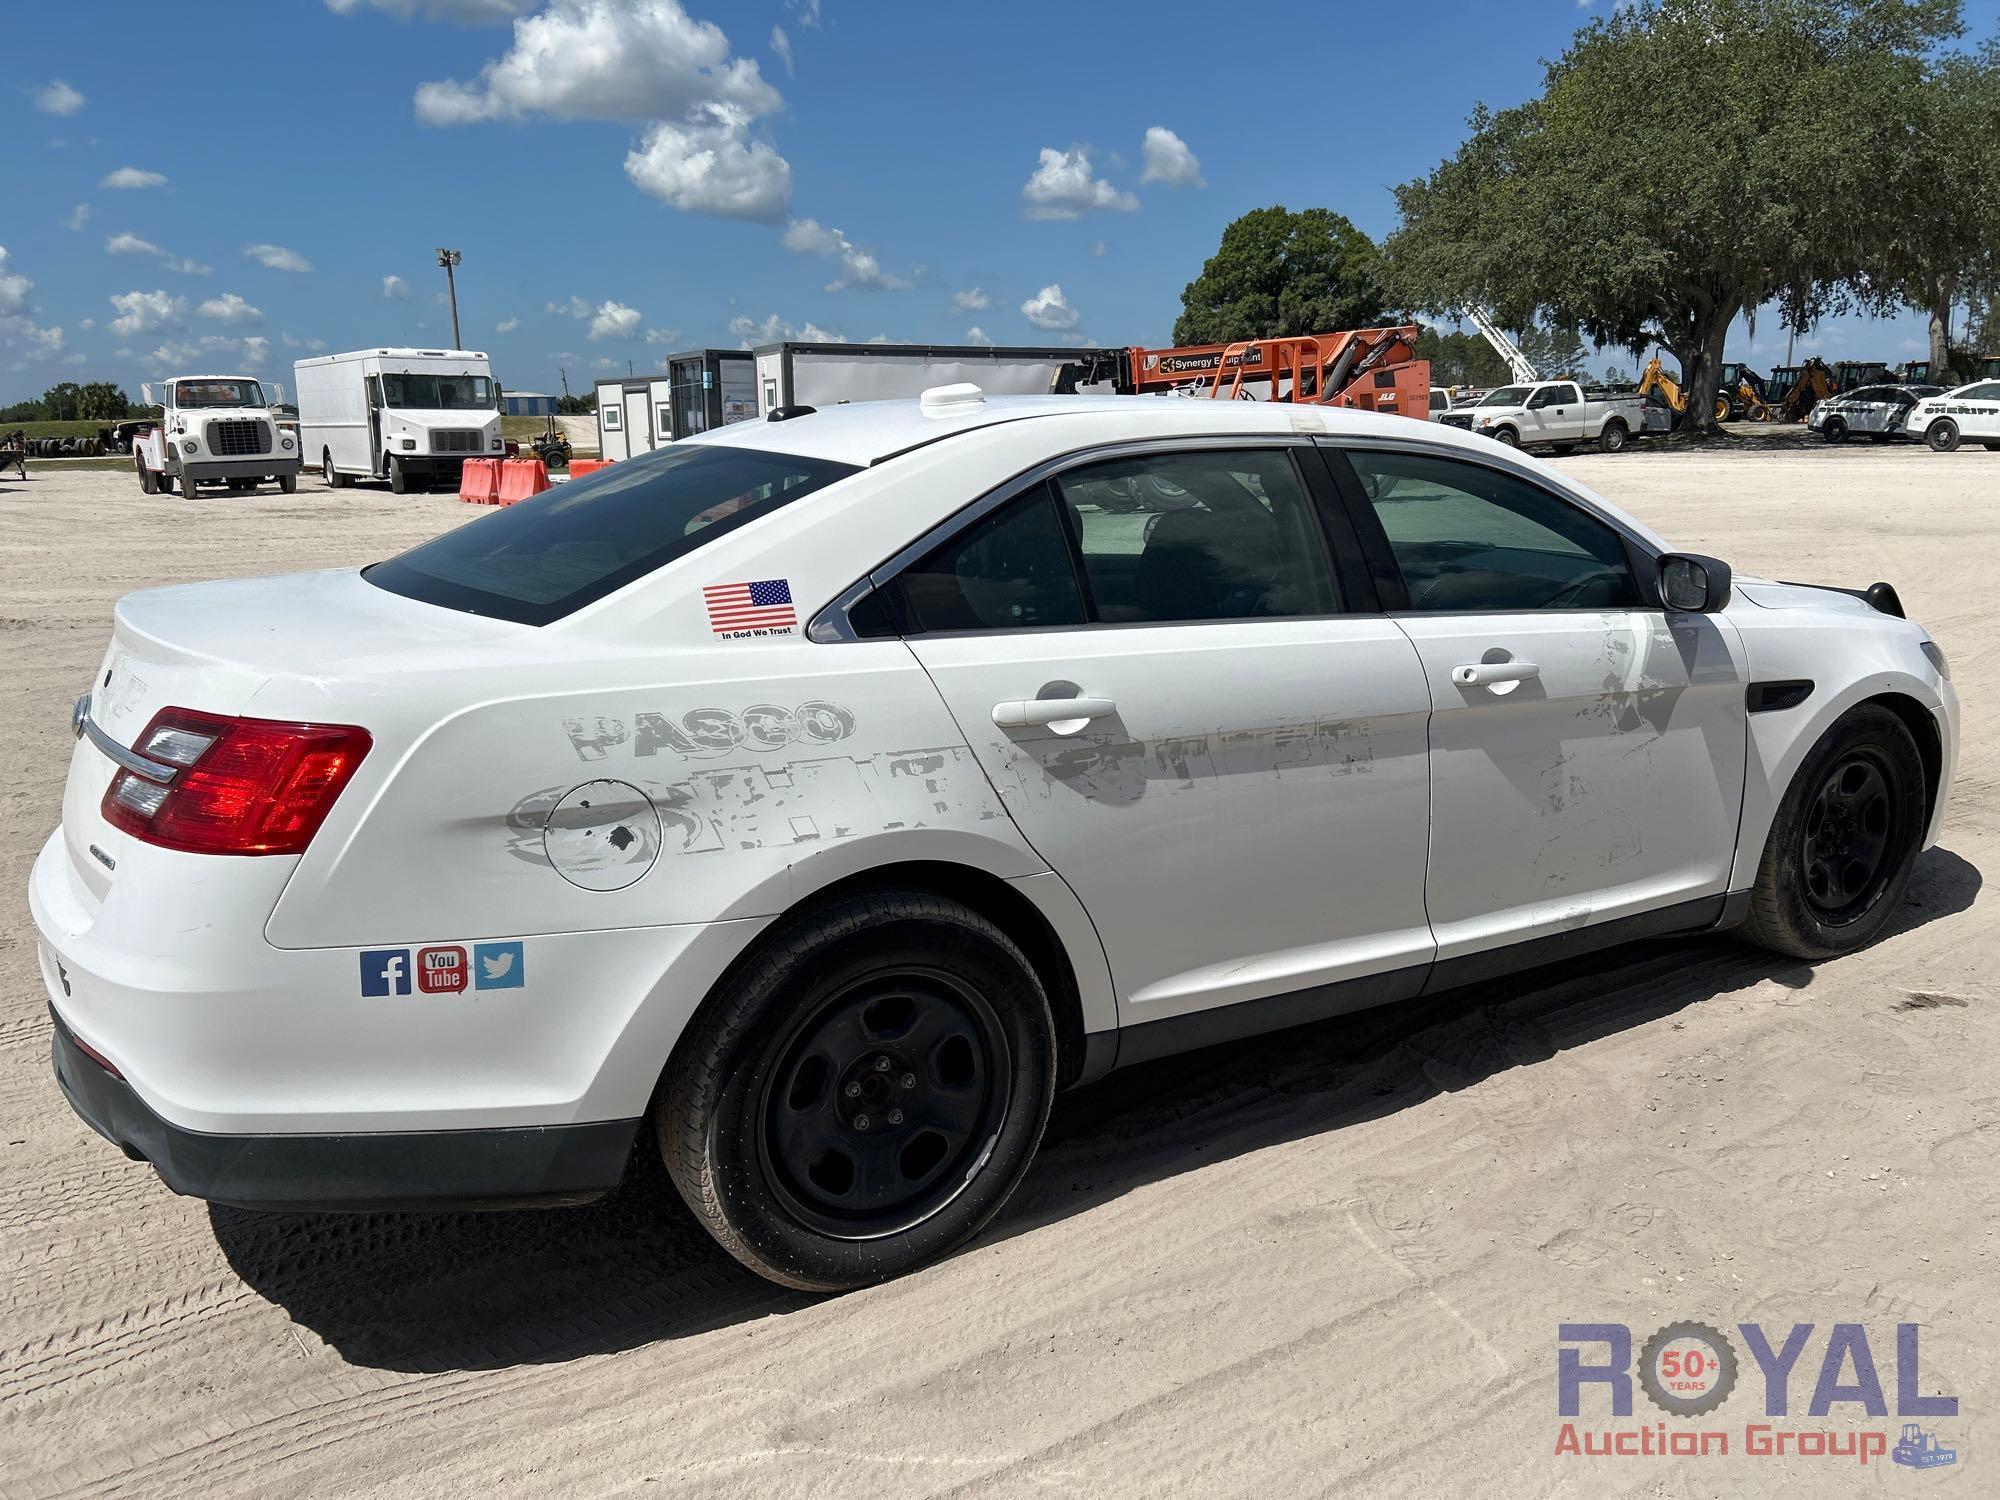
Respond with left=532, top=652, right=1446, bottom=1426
left=210, top=850, right=1980, bottom=1372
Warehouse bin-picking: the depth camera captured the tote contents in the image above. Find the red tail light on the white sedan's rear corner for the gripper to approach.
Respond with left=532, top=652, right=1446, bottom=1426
left=104, top=708, right=374, bottom=854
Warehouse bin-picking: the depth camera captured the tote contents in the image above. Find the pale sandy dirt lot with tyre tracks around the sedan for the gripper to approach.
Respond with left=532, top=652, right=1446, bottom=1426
left=0, top=444, right=2000, bottom=1500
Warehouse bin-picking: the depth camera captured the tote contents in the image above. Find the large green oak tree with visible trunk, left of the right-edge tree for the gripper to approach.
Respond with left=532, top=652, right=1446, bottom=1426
left=1384, top=0, right=1960, bottom=426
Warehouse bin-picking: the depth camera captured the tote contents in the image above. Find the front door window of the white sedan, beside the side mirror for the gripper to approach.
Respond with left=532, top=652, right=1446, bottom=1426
left=1348, top=452, right=1644, bottom=612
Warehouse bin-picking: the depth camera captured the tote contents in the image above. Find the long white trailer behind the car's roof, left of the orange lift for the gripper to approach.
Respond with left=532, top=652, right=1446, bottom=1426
left=756, top=344, right=1112, bottom=416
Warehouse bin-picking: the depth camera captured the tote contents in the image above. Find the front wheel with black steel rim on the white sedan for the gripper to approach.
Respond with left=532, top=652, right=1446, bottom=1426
left=1744, top=704, right=1930, bottom=958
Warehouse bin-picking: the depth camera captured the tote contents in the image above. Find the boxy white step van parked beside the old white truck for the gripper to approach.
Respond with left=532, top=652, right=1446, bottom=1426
left=292, top=348, right=506, bottom=494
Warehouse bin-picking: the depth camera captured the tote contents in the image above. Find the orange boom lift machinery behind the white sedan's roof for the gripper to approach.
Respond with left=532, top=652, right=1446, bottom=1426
left=1054, top=324, right=1430, bottom=420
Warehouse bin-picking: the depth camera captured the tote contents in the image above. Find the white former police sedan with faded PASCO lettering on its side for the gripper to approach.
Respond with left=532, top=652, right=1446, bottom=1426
left=30, top=386, right=1958, bottom=1288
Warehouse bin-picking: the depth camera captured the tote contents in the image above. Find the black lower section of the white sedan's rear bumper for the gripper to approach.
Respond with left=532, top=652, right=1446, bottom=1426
left=48, top=1006, right=640, bottom=1212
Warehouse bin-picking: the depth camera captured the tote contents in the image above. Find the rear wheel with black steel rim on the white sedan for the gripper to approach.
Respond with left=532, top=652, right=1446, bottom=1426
left=656, top=890, right=1056, bottom=1292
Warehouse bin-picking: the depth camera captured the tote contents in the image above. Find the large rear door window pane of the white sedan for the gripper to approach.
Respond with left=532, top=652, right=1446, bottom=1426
left=1054, top=448, right=1340, bottom=624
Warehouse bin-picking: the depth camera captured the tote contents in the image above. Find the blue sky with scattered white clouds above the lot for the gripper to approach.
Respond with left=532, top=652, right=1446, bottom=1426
left=0, top=0, right=2000, bottom=404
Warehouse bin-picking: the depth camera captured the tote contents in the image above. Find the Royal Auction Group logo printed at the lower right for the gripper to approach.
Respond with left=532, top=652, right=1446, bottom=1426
left=1556, top=1320, right=1958, bottom=1468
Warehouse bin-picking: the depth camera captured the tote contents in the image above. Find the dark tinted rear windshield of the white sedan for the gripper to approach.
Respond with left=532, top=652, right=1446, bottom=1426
left=362, top=444, right=856, bottom=624
